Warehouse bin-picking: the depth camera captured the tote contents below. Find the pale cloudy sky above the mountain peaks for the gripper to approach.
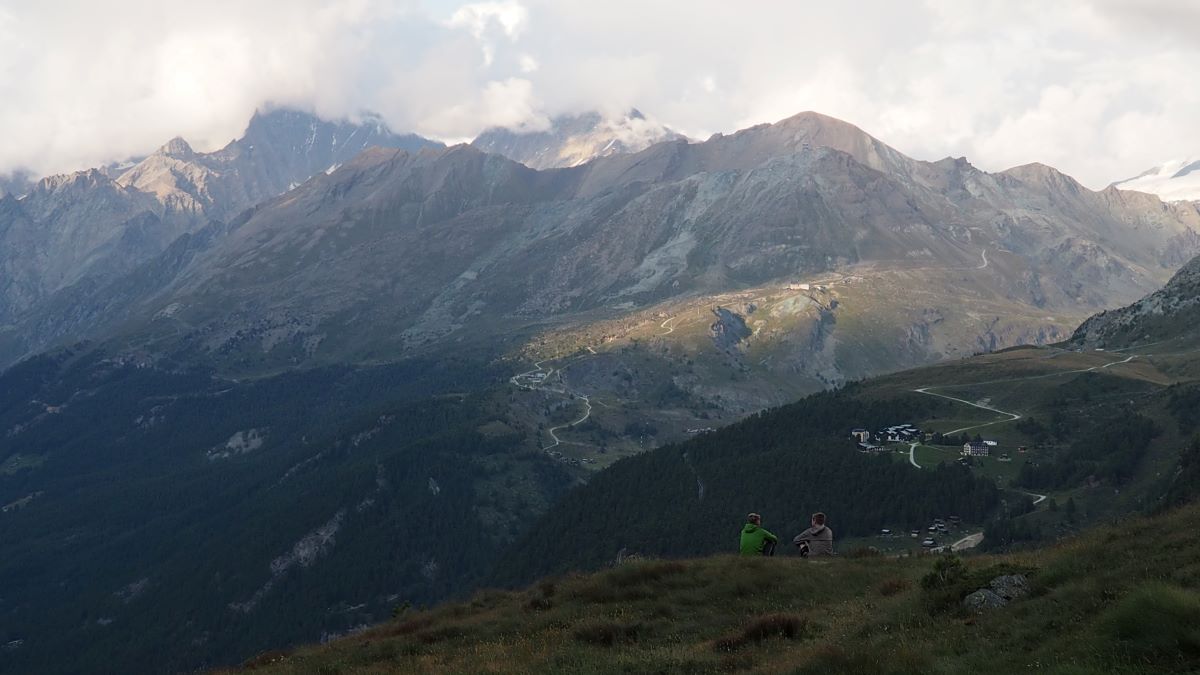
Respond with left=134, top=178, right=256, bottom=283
left=0, top=0, right=1200, bottom=189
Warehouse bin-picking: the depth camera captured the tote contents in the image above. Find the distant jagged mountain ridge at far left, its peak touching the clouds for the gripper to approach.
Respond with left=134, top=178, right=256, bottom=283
left=0, top=108, right=437, bottom=356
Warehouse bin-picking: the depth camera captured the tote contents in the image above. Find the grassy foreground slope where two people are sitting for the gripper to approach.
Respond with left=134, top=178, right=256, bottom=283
left=220, top=497, right=1200, bottom=675
